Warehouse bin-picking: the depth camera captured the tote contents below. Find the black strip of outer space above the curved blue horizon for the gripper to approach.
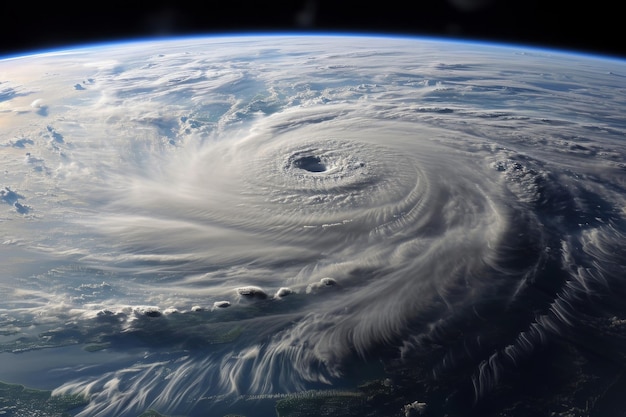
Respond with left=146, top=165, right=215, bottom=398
left=0, top=0, right=626, bottom=57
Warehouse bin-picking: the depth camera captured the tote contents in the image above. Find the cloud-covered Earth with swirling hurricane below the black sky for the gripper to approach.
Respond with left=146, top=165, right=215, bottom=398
left=0, top=34, right=626, bottom=417
